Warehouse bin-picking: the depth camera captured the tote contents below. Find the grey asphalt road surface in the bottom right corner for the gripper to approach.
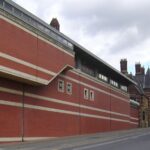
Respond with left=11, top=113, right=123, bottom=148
left=70, top=134, right=150, bottom=150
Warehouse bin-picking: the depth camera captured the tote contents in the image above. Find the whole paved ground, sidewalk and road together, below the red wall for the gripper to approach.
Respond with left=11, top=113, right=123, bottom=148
left=0, top=128, right=150, bottom=150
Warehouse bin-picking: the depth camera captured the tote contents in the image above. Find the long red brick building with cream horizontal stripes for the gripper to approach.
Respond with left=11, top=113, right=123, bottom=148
left=0, top=0, right=139, bottom=142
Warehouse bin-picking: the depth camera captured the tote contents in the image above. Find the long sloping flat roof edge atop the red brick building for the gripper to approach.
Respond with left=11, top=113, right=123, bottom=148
left=2, top=0, right=136, bottom=84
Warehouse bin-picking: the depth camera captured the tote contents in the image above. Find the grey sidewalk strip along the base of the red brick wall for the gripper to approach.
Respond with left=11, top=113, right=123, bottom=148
left=0, top=128, right=150, bottom=150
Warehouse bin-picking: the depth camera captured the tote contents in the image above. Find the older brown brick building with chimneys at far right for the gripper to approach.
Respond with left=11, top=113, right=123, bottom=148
left=120, top=59, right=150, bottom=127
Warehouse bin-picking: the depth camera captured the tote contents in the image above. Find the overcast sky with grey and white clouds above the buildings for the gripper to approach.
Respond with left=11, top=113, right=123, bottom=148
left=14, top=0, right=150, bottom=72
